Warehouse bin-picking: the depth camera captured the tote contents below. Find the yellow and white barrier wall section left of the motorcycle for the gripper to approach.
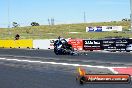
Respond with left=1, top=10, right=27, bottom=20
left=0, top=39, right=56, bottom=49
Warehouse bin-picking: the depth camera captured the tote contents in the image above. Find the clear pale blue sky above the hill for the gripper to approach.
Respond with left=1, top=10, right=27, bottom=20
left=0, top=0, right=130, bottom=28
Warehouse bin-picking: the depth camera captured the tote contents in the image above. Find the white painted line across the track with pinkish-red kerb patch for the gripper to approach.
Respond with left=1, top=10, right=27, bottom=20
left=0, top=58, right=132, bottom=75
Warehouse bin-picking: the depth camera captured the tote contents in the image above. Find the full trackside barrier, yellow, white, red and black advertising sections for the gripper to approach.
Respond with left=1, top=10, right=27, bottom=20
left=0, top=38, right=132, bottom=51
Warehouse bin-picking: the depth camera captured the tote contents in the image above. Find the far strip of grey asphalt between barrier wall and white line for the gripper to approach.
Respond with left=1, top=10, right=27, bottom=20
left=0, top=49, right=132, bottom=66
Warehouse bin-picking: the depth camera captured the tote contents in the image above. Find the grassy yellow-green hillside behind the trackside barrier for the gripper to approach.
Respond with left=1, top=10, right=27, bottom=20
left=0, top=22, right=132, bottom=39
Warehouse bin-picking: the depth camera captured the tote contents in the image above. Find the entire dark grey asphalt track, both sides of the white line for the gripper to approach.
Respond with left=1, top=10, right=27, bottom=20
left=0, top=49, right=132, bottom=88
